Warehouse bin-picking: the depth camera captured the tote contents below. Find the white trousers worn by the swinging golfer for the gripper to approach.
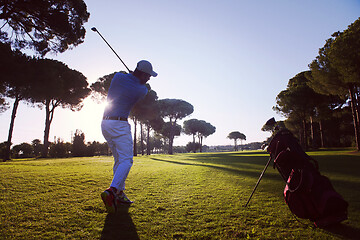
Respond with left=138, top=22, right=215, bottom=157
left=101, top=120, right=133, bottom=191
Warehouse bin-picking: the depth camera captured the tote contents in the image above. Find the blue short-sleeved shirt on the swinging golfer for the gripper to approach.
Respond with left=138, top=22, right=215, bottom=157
left=104, top=72, right=148, bottom=118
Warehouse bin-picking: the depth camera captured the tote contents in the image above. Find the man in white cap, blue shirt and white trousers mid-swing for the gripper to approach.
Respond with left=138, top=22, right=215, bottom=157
left=101, top=60, right=157, bottom=212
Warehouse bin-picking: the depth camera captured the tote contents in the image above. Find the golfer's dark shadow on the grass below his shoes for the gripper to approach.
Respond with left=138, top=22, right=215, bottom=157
left=100, top=206, right=140, bottom=240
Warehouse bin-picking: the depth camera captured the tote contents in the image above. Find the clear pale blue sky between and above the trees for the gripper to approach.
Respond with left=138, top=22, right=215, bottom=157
left=0, top=0, right=360, bottom=145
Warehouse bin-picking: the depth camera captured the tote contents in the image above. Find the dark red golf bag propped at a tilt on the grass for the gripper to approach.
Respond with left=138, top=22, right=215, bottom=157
left=267, top=129, right=348, bottom=227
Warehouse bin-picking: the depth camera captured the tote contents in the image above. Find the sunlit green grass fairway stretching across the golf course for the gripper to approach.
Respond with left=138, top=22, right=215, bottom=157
left=0, top=151, right=360, bottom=239
